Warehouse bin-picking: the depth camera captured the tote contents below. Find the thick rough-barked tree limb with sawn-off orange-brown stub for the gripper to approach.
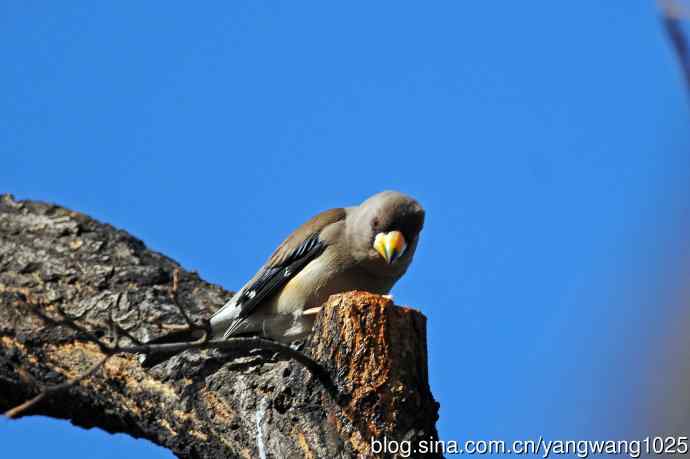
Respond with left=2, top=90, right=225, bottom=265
left=0, top=195, right=438, bottom=458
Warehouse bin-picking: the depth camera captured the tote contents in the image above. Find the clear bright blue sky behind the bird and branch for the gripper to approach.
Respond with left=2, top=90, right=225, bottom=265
left=0, top=0, right=690, bottom=459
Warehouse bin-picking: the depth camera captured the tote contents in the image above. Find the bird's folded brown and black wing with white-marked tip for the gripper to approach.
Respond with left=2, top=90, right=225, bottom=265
left=214, top=208, right=345, bottom=338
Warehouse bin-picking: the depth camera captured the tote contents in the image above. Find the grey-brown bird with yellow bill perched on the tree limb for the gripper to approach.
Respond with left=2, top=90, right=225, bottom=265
left=142, top=191, right=425, bottom=366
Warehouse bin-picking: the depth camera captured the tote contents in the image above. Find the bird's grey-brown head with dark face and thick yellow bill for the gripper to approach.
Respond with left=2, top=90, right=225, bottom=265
left=348, top=191, right=424, bottom=278
